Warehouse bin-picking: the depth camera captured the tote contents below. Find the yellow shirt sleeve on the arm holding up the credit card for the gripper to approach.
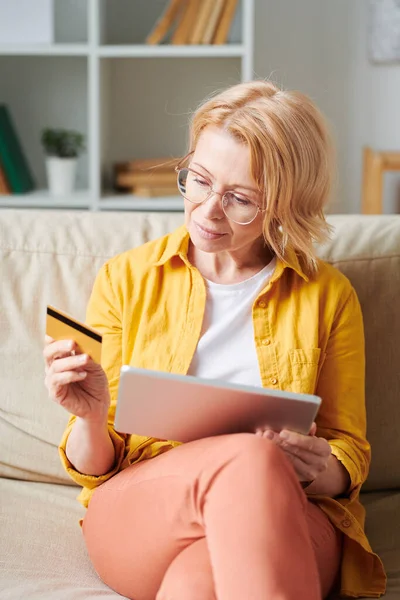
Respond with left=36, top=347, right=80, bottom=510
left=59, top=263, right=129, bottom=489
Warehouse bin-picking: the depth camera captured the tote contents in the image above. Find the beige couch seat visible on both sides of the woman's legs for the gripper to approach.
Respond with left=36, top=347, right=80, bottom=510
left=0, top=479, right=400, bottom=600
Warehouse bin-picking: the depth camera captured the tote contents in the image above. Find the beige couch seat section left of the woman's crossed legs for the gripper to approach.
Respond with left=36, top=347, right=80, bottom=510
left=0, top=479, right=123, bottom=600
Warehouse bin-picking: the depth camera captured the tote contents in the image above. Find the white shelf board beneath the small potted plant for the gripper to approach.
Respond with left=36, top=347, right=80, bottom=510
left=0, top=190, right=91, bottom=209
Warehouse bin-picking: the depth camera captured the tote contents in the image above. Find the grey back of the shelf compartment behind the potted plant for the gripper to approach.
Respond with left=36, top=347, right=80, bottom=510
left=0, top=56, right=88, bottom=189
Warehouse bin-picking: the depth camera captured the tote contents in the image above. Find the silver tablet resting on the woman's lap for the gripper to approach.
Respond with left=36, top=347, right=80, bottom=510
left=114, top=366, right=321, bottom=442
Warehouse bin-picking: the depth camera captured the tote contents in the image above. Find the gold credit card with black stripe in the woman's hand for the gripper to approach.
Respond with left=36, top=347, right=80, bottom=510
left=46, top=306, right=102, bottom=364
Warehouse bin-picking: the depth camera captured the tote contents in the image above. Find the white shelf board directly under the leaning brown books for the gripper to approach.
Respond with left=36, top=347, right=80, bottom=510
left=97, top=44, right=245, bottom=58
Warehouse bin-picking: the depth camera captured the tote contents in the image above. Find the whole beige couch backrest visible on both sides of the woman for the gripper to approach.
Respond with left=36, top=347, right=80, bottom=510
left=0, top=210, right=400, bottom=489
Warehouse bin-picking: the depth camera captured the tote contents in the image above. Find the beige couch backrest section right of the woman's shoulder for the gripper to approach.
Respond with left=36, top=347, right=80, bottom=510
left=319, top=215, right=400, bottom=491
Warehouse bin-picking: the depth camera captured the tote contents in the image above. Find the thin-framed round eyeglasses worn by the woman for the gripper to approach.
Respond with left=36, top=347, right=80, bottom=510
left=175, top=153, right=265, bottom=225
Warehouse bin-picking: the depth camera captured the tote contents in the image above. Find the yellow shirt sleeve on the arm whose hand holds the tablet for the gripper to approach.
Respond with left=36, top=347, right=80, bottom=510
left=316, top=287, right=371, bottom=496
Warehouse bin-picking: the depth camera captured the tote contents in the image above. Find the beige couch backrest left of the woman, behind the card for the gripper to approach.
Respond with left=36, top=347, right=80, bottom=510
left=0, top=210, right=183, bottom=484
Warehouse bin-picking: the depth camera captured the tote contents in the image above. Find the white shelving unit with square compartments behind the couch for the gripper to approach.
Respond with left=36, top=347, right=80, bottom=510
left=0, top=0, right=254, bottom=211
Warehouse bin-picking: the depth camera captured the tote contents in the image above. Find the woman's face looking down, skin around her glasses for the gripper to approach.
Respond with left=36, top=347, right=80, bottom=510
left=185, top=126, right=263, bottom=252
